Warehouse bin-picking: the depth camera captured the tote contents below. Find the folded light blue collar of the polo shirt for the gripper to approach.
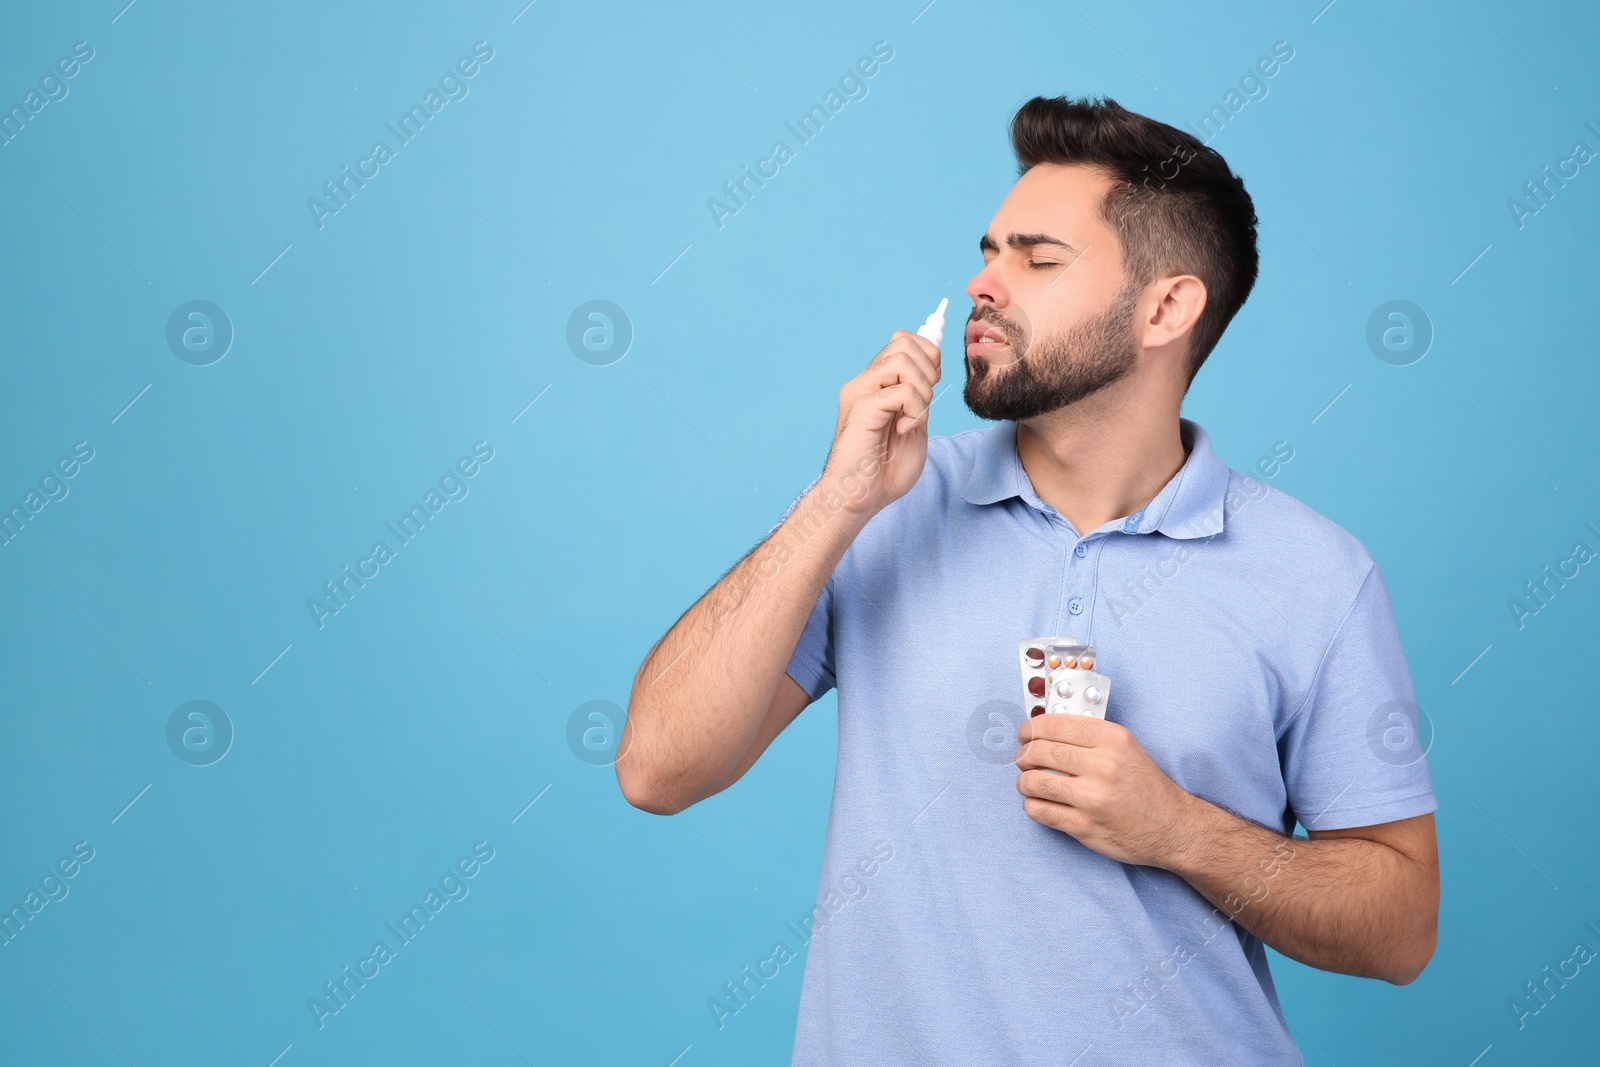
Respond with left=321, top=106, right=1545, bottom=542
left=962, top=418, right=1229, bottom=537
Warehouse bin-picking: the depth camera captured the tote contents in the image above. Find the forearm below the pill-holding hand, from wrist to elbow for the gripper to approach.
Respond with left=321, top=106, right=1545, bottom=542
left=1157, top=797, right=1438, bottom=984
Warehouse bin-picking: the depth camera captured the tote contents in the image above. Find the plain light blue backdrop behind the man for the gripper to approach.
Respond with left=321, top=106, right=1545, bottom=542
left=0, top=0, right=1600, bottom=1067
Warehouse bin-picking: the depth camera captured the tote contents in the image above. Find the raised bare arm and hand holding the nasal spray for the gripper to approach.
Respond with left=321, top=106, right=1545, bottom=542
left=616, top=330, right=939, bottom=814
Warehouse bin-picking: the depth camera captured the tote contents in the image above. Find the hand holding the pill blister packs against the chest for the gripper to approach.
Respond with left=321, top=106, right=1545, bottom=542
left=1016, top=712, right=1197, bottom=867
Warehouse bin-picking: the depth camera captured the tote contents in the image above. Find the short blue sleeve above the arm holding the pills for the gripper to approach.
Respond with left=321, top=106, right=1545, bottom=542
left=1278, top=563, right=1438, bottom=830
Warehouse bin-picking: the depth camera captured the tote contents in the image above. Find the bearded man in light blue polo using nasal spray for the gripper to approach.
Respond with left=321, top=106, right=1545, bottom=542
left=616, top=98, right=1438, bottom=1067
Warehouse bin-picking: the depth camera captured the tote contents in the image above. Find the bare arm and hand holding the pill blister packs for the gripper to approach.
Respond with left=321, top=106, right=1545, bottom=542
left=1016, top=715, right=1438, bottom=985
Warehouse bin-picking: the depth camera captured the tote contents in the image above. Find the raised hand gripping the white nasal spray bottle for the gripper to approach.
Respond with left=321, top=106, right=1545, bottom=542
left=822, top=330, right=939, bottom=515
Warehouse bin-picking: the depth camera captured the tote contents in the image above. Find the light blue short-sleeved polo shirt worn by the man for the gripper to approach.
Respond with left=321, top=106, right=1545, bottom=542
left=774, top=419, right=1438, bottom=1067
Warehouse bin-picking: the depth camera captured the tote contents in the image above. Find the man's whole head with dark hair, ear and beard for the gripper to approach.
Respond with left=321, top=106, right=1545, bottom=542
left=963, top=96, right=1258, bottom=419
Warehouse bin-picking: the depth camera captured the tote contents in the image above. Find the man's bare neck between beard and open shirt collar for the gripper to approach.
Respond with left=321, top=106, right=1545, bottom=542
left=1016, top=387, right=1189, bottom=534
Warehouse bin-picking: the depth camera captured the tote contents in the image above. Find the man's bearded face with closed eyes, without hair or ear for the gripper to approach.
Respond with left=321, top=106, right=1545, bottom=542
left=962, top=165, right=1139, bottom=419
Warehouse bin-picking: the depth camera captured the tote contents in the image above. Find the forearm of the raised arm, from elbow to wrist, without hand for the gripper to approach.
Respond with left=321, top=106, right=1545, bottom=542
left=618, top=477, right=866, bottom=811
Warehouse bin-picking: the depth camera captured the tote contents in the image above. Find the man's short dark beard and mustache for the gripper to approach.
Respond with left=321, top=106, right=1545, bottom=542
left=962, top=286, right=1139, bottom=421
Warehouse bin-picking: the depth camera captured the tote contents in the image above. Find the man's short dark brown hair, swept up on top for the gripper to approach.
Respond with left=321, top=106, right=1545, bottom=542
left=1011, top=96, right=1259, bottom=389
